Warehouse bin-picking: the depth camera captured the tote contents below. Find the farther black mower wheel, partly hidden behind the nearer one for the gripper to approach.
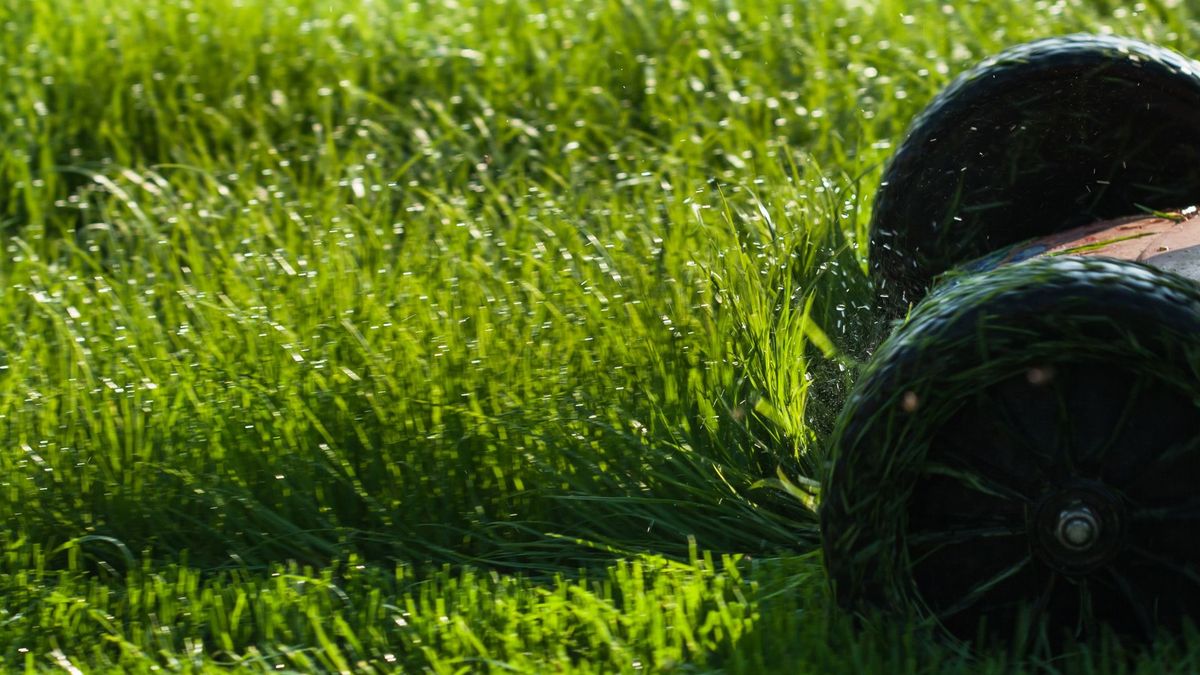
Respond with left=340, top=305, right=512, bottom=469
left=870, top=35, right=1200, bottom=307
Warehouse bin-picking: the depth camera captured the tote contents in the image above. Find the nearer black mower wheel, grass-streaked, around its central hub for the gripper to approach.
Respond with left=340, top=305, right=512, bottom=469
left=821, top=257, right=1200, bottom=641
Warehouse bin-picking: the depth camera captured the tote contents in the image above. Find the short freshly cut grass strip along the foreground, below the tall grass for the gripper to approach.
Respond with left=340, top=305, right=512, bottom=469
left=7, top=542, right=1200, bottom=674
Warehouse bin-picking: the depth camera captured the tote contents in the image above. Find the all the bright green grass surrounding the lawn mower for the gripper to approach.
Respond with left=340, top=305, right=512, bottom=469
left=0, top=0, right=1200, bottom=673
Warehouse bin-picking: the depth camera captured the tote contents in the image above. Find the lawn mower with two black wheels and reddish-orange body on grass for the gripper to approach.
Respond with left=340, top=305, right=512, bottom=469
left=821, top=35, right=1200, bottom=641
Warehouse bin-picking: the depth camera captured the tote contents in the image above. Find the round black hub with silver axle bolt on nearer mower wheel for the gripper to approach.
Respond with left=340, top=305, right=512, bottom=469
left=1028, top=480, right=1127, bottom=577
